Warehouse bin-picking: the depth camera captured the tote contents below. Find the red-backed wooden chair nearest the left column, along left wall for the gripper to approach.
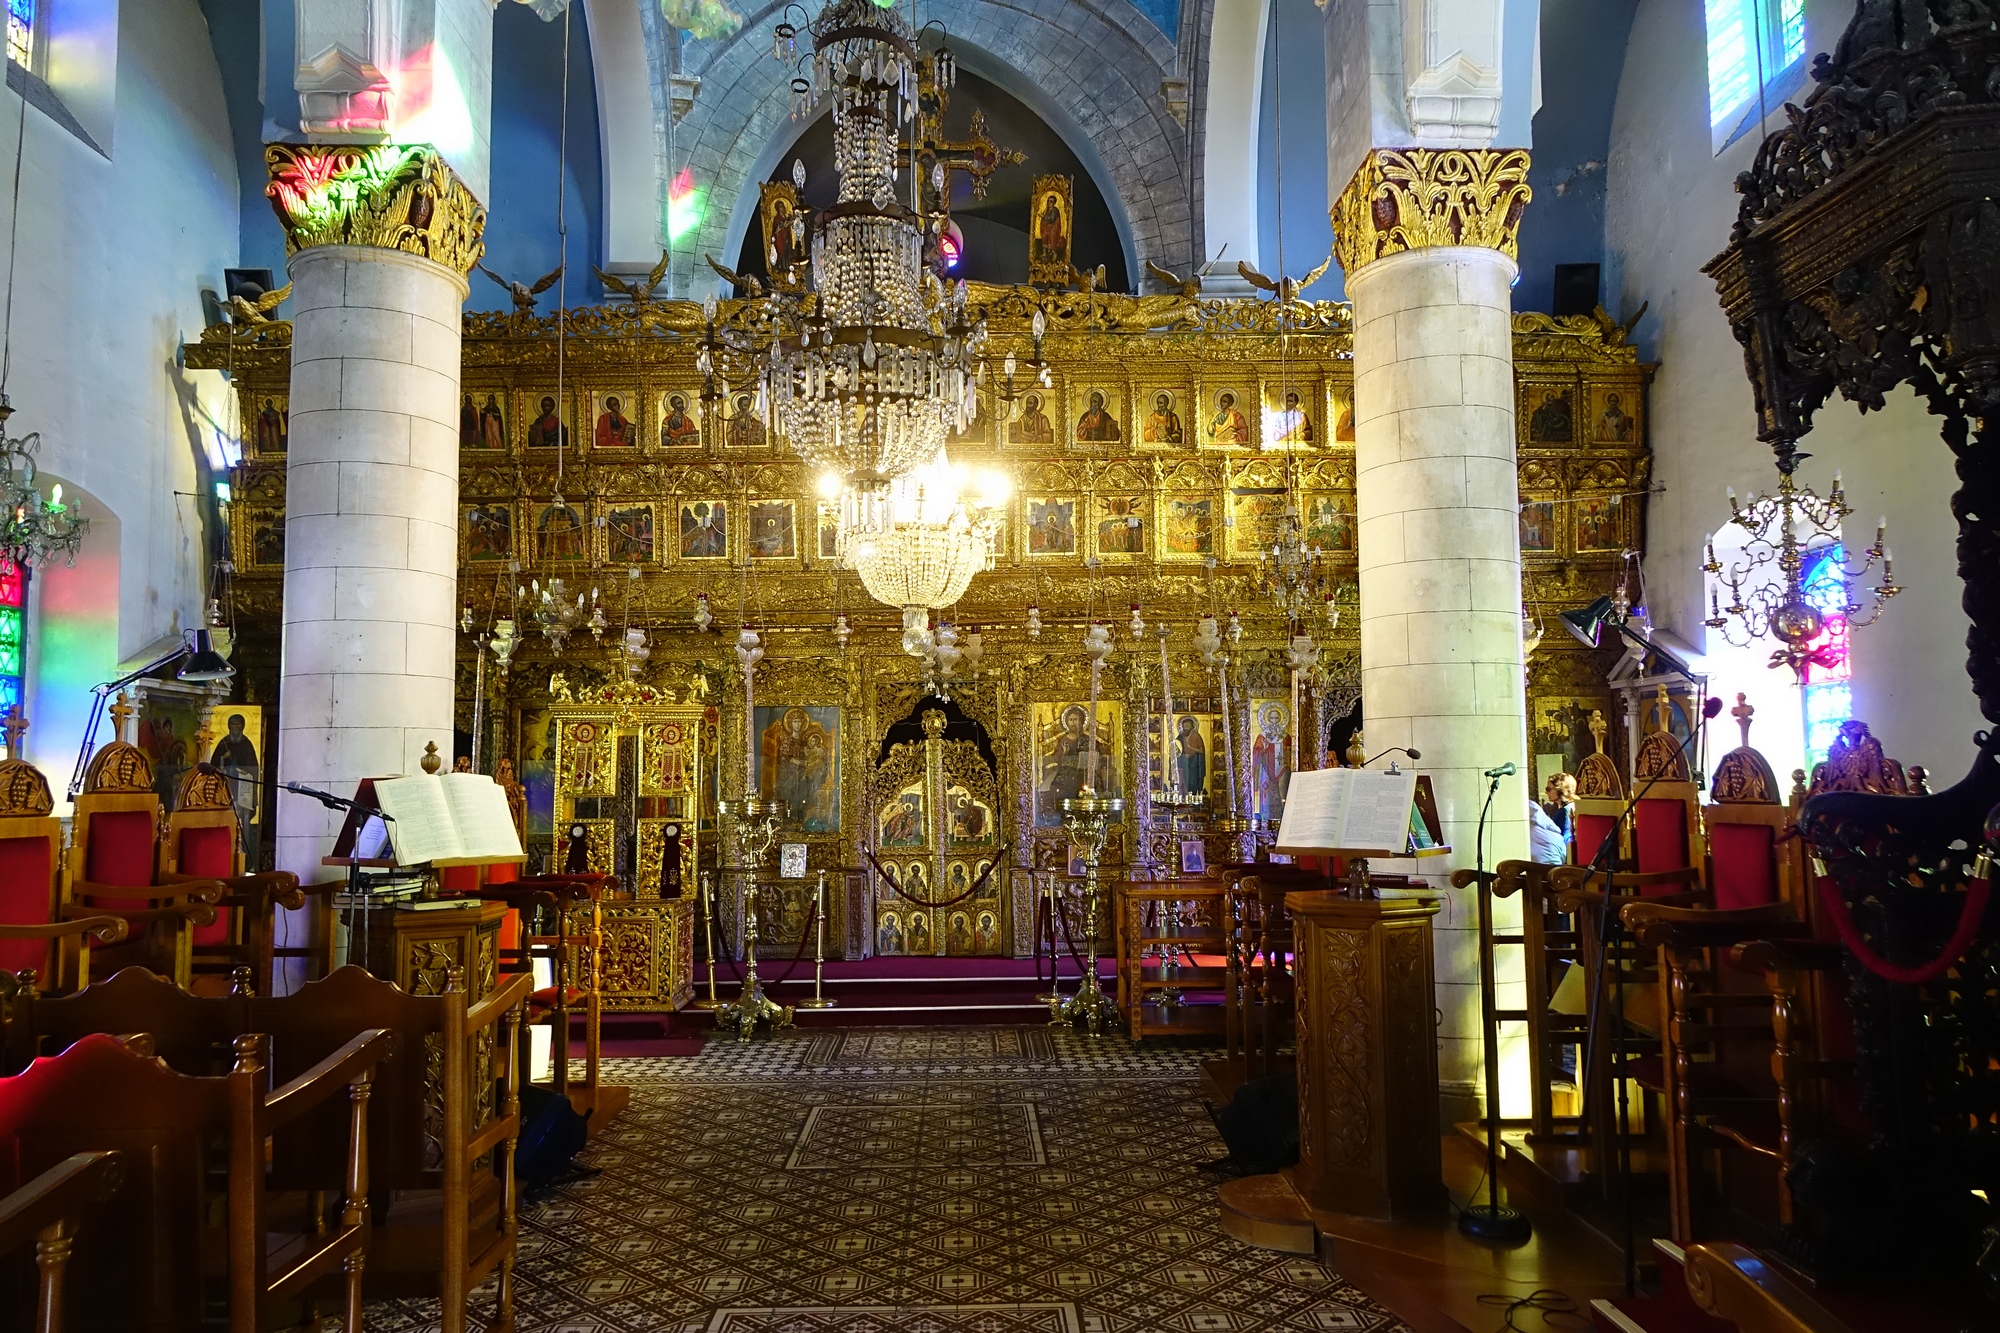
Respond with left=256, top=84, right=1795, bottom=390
left=158, top=756, right=306, bottom=995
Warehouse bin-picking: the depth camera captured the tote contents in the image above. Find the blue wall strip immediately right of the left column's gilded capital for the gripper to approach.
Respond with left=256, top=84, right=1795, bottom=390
left=466, top=4, right=604, bottom=312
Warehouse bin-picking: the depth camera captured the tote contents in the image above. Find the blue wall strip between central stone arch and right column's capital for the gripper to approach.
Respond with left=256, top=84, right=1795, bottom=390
left=1248, top=0, right=1344, bottom=300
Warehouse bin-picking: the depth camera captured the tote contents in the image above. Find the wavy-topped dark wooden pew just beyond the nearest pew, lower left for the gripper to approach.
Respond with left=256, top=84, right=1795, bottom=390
left=6, top=967, right=532, bottom=1333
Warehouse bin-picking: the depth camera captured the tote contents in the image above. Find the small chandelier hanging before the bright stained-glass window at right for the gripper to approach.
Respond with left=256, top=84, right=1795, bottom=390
left=1702, top=468, right=1902, bottom=681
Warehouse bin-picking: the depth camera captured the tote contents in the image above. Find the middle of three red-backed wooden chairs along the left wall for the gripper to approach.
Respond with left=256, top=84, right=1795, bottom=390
left=62, top=695, right=228, bottom=987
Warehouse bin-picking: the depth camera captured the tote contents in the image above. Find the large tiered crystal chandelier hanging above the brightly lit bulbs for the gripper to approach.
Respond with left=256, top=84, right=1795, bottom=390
left=762, top=0, right=986, bottom=488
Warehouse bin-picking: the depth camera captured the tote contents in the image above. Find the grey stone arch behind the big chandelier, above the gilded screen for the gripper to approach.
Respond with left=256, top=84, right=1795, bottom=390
left=662, top=0, right=1192, bottom=296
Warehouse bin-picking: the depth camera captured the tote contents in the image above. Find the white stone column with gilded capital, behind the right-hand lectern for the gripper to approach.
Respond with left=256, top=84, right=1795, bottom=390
left=1332, top=148, right=1528, bottom=1119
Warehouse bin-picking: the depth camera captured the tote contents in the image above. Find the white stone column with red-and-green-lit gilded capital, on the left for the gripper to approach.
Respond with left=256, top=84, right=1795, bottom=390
left=266, top=144, right=486, bottom=879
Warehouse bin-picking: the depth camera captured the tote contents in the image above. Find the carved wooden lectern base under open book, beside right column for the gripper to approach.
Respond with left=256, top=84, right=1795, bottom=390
left=1284, top=891, right=1444, bottom=1217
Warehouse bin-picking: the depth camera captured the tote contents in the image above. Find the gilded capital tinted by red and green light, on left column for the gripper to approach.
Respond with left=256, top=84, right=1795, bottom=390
left=264, top=144, right=486, bottom=274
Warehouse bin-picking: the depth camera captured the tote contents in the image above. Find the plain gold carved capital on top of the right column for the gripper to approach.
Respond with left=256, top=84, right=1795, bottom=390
left=1332, top=148, right=1532, bottom=276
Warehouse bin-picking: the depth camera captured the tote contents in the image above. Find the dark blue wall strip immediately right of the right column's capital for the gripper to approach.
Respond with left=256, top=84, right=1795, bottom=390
left=1514, top=0, right=1640, bottom=314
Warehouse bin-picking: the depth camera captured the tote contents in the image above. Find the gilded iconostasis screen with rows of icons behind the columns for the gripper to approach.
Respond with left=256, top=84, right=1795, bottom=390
left=188, top=286, right=1652, bottom=955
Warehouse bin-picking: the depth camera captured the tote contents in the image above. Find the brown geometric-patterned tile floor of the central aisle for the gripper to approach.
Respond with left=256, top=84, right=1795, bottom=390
left=368, top=1029, right=1408, bottom=1333
